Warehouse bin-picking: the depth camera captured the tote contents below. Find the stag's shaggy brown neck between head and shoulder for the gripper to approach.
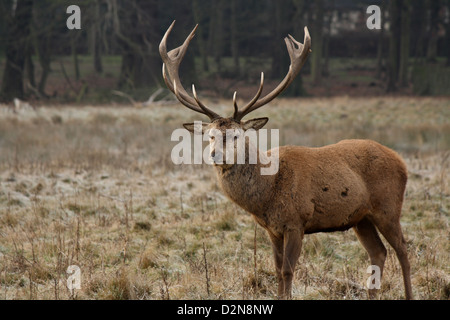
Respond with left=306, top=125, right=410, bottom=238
left=215, top=146, right=276, bottom=215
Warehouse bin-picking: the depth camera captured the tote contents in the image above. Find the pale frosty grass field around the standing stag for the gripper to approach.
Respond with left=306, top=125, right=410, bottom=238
left=0, top=98, right=450, bottom=299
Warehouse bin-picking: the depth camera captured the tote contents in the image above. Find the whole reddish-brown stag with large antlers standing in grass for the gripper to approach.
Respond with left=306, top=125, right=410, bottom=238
left=159, top=21, right=413, bottom=299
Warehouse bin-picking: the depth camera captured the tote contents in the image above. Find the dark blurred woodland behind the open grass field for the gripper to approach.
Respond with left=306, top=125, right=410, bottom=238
left=0, top=0, right=450, bottom=103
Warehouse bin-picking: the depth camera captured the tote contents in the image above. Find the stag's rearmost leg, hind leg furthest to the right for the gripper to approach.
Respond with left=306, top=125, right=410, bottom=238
left=375, top=220, right=413, bottom=300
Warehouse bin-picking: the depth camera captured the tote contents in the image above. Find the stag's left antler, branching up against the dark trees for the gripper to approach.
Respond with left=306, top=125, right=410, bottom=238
left=159, top=20, right=220, bottom=120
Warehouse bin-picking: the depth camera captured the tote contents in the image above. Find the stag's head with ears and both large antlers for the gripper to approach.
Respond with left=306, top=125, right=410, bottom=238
left=159, top=21, right=311, bottom=166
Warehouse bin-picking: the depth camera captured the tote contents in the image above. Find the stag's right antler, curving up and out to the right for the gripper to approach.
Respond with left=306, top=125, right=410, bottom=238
left=233, top=27, right=311, bottom=122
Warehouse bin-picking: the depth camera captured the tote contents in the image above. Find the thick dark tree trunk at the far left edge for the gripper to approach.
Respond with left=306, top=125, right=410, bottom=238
left=0, top=0, right=33, bottom=101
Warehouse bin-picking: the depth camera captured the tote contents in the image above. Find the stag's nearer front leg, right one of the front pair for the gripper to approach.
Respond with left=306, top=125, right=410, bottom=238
left=281, top=229, right=303, bottom=299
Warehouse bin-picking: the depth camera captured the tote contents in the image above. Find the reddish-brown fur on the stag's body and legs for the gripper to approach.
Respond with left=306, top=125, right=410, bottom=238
left=193, top=118, right=412, bottom=299
